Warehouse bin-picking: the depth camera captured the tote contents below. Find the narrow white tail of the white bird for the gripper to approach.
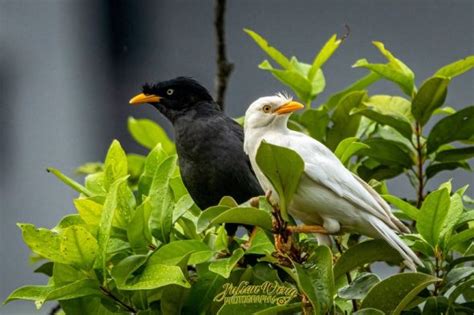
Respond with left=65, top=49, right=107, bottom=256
left=369, top=216, right=423, bottom=271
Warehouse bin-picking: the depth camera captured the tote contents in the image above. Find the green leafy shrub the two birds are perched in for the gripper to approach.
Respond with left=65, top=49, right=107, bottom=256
left=5, top=30, right=474, bottom=314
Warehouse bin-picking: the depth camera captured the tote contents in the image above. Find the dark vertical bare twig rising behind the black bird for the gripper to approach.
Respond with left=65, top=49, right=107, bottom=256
left=214, top=0, right=234, bottom=110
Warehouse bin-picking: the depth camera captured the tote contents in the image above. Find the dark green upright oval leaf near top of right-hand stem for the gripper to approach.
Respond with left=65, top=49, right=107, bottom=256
left=411, top=77, right=450, bottom=126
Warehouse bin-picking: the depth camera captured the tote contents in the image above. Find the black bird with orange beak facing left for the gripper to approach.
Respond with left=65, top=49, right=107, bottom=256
left=130, top=77, right=263, bottom=235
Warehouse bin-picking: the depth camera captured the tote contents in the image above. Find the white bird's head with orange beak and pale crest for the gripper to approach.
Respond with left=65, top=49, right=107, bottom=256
left=244, top=93, right=304, bottom=129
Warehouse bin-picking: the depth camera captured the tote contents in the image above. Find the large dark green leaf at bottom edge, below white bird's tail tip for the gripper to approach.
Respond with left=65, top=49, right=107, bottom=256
left=361, top=273, right=440, bottom=314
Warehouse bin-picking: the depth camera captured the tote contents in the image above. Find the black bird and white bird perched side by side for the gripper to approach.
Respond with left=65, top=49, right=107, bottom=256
left=130, top=77, right=422, bottom=270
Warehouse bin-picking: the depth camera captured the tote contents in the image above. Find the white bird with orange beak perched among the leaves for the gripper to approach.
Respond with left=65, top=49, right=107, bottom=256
left=244, top=94, right=423, bottom=270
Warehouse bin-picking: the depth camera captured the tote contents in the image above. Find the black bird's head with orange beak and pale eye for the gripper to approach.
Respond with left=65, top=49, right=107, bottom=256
left=130, top=77, right=214, bottom=119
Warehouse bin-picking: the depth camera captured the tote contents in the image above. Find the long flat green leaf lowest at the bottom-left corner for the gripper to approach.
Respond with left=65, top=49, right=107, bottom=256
left=4, top=279, right=100, bottom=309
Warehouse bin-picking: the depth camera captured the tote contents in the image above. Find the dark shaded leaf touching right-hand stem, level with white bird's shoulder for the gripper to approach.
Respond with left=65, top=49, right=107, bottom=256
left=358, top=138, right=413, bottom=168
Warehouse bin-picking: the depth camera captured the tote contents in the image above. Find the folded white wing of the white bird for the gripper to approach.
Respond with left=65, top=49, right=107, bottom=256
left=287, top=132, right=400, bottom=230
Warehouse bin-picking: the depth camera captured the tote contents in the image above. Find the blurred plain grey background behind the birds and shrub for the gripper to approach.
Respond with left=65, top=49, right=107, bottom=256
left=0, top=0, right=474, bottom=314
